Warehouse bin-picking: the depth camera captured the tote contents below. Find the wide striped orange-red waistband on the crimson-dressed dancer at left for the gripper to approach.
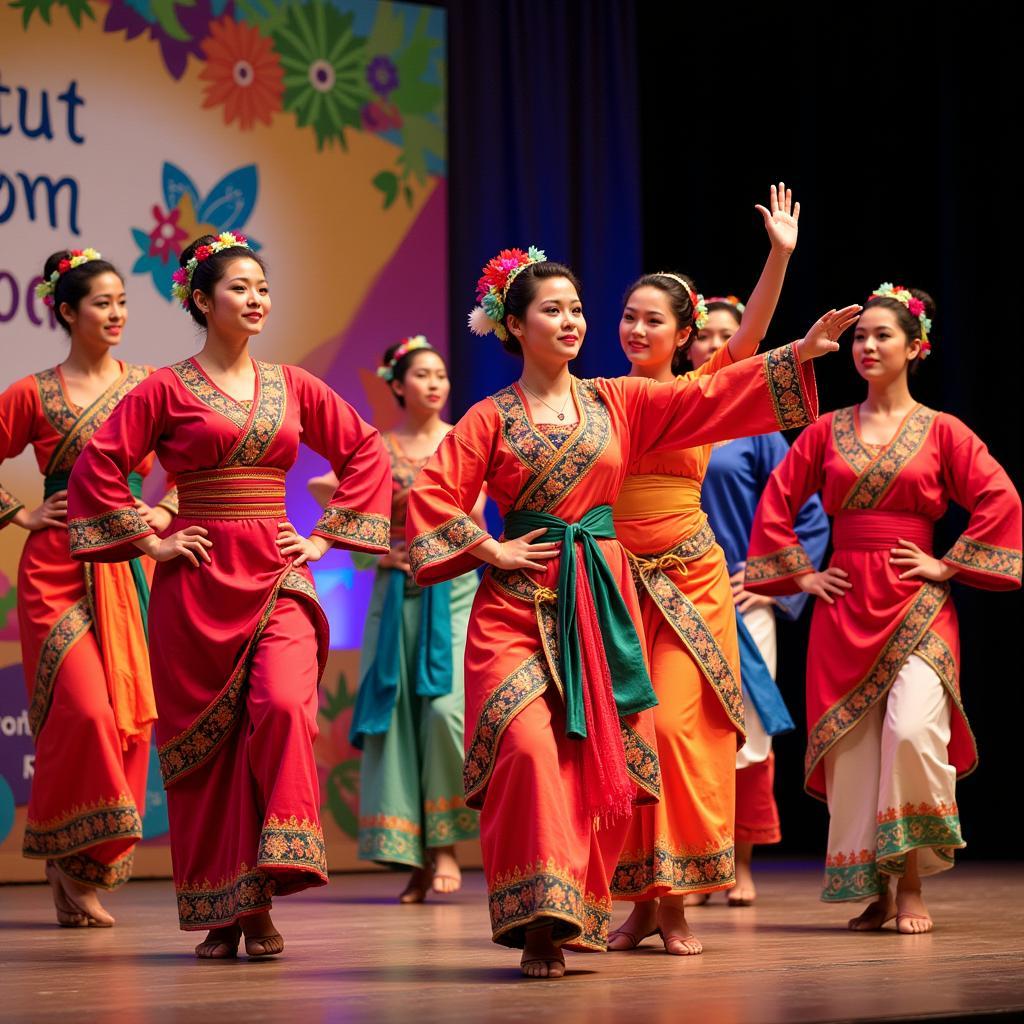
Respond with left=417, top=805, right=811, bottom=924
left=174, top=466, right=286, bottom=519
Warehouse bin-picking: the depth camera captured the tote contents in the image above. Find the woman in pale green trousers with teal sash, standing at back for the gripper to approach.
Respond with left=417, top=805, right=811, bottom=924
left=309, top=335, right=483, bottom=903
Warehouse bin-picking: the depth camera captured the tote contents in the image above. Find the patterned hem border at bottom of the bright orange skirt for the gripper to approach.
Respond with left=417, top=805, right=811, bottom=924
left=610, top=836, right=736, bottom=898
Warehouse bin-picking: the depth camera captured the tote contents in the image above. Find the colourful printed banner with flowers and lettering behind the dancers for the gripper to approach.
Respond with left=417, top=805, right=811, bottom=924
left=0, top=0, right=456, bottom=882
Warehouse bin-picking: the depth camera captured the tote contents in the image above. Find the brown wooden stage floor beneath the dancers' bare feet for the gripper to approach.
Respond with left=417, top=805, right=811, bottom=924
left=0, top=862, right=1024, bottom=1024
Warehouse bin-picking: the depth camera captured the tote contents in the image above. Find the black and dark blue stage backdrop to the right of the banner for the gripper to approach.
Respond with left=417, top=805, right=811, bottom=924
left=444, top=0, right=1024, bottom=859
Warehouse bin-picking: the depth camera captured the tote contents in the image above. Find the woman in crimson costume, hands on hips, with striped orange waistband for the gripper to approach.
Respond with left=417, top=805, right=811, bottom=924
left=68, top=232, right=390, bottom=957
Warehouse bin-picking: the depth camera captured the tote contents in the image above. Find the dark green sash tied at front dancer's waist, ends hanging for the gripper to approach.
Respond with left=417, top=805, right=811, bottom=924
left=505, top=505, right=657, bottom=739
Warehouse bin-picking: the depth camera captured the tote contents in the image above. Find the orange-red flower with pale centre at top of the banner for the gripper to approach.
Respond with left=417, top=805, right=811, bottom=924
left=199, top=16, right=285, bottom=131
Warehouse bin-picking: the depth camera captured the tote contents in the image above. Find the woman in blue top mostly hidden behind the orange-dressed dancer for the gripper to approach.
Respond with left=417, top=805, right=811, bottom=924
left=686, top=296, right=828, bottom=906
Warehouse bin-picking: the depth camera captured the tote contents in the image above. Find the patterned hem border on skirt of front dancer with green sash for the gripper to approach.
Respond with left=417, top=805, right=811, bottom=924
left=487, top=859, right=611, bottom=950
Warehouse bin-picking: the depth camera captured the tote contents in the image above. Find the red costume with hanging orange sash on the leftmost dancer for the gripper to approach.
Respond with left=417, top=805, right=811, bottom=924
left=0, top=364, right=156, bottom=889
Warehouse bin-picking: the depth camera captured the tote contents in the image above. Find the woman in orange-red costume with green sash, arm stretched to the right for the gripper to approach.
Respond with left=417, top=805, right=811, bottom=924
left=407, top=243, right=850, bottom=977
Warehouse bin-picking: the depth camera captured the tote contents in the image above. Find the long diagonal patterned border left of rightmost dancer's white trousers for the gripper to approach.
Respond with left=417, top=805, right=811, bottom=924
left=804, top=583, right=949, bottom=799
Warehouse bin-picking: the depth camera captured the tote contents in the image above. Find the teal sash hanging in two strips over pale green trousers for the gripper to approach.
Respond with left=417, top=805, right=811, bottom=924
left=348, top=569, right=453, bottom=750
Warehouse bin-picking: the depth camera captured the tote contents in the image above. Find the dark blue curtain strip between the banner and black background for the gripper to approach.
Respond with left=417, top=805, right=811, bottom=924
left=446, top=0, right=643, bottom=416
